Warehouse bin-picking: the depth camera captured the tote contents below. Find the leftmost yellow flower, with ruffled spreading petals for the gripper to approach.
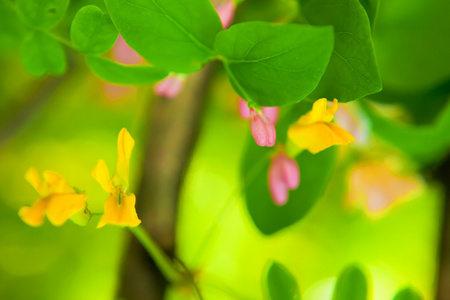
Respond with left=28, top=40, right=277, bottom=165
left=19, top=168, right=86, bottom=226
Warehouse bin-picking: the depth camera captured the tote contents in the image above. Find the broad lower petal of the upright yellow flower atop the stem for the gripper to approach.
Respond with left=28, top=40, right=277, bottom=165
left=97, top=194, right=141, bottom=228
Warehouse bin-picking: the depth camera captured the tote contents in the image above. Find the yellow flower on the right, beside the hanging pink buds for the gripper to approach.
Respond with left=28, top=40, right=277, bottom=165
left=288, top=98, right=355, bottom=153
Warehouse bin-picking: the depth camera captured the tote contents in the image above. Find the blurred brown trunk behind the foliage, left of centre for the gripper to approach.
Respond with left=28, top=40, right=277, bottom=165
left=119, top=63, right=215, bottom=300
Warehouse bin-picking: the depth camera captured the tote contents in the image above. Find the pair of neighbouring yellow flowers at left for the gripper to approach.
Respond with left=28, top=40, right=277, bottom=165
left=19, top=128, right=141, bottom=228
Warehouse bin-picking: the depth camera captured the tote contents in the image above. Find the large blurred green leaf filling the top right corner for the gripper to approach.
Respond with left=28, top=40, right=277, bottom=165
left=374, top=0, right=450, bottom=93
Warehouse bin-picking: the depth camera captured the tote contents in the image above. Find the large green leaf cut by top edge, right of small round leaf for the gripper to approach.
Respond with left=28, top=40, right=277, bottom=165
left=105, top=0, right=222, bottom=73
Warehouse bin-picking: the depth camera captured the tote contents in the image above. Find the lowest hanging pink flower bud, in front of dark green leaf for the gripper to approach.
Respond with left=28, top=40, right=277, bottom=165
left=268, top=152, right=300, bottom=205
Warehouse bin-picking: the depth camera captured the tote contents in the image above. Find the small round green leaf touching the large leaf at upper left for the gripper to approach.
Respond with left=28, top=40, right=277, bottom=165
left=70, top=5, right=119, bottom=54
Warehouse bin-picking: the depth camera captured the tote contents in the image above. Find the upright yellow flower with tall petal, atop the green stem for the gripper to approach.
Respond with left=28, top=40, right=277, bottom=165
left=92, top=128, right=141, bottom=228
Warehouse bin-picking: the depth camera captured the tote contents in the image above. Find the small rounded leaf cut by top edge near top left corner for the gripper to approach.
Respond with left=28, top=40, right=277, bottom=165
left=16, top=0, right=69, bottom=29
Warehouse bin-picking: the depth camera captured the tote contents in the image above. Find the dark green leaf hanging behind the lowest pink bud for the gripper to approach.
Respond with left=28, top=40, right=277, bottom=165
left=242, top=101, right=337, bottom=235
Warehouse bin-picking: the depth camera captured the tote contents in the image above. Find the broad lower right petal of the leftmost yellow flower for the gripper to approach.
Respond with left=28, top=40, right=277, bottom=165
left=46, top=194, right=86, bottom=226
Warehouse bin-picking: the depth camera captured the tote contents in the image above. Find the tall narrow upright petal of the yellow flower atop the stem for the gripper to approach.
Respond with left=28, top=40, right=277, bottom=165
left=112, top=128, right=134, bottom=190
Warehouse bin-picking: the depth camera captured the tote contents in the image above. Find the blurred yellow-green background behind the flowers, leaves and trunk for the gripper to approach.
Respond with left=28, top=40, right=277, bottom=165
left=0, top=0, right=450, bottom=300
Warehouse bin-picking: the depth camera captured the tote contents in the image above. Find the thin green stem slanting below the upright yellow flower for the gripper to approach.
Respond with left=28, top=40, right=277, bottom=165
left=128, top=226, right=184, bottom=283
